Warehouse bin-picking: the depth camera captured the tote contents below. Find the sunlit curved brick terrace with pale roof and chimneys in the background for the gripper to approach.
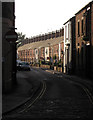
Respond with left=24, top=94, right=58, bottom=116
left=18, top=28, right=64, bottom=70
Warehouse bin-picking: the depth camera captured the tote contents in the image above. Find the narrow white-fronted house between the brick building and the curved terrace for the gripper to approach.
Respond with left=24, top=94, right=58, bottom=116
left=64, top=16, right=76, bottom=73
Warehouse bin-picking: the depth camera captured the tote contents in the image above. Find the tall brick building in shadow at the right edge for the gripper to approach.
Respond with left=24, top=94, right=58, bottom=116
left=75, top=1, right=93, bottom=77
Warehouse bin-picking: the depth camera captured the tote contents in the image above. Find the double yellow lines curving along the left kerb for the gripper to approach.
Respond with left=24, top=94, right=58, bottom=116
left=19, top=81, right=46, bottom=113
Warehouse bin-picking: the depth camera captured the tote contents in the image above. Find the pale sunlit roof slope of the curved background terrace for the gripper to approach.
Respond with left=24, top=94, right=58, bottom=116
left=18, top=36, right=64, bottom=51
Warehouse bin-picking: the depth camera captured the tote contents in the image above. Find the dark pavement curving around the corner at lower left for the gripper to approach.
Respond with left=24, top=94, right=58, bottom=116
left=2, top=72, right=41, bottom=114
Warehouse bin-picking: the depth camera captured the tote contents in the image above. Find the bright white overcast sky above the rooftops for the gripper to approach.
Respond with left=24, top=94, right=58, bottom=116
left=15, top=0, right=92, bottom=38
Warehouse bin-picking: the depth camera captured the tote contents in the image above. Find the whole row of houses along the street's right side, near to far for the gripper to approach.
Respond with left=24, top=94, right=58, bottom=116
left=17, top=1, right=93, bottom=77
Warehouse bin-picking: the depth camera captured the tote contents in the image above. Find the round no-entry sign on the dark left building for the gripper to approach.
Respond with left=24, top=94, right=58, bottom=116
left=5, top=30, right=18, bottom=42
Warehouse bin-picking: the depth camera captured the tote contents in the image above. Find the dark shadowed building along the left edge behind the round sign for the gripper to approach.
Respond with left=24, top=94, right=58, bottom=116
left=2, top=2, right=16, bottom=92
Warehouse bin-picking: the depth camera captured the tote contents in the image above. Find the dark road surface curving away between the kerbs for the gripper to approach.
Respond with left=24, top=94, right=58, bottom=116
left=4, top=68, right=93, bottom=119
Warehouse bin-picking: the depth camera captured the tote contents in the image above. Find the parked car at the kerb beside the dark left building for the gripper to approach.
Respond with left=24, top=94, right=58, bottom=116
left=17, top=61, right=30, bottom=71
